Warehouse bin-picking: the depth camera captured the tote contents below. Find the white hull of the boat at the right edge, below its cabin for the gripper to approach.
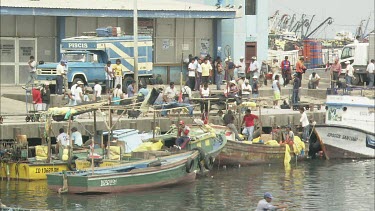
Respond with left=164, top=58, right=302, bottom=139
left=315, top=125, right=375, bottom=159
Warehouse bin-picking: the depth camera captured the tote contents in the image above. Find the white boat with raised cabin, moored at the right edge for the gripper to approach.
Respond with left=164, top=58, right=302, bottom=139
left=315, top=95, right=375, bottom=159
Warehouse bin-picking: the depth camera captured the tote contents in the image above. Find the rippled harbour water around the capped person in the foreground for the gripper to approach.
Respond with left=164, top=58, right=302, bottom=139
left=0, top=160, right=375, bottom=211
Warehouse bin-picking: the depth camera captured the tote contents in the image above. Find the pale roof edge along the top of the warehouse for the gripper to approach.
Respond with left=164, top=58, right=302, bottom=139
left=1, top=0, right=236, bottom=11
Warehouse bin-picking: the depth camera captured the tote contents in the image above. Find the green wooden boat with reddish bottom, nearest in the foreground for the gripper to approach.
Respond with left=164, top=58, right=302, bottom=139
left=47, top=151, right=199, bottom=193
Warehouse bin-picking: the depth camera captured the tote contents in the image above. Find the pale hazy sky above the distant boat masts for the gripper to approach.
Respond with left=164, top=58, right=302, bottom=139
left=268, top=0, right=375, bottom=38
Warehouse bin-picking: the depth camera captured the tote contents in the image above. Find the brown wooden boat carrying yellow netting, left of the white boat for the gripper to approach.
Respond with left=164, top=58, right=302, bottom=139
left=215, top=126, right=309, bottom=166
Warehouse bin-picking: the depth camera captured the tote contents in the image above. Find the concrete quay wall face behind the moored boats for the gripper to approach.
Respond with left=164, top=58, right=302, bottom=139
left=0, top=109, right=325, bottom=140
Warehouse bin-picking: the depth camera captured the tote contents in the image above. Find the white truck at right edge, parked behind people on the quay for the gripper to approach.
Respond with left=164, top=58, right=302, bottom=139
left=340, top=33, right=375, bottom=85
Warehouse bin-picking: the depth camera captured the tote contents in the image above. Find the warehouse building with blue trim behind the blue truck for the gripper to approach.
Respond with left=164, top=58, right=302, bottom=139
left=0, top=0, right=268, bottom=85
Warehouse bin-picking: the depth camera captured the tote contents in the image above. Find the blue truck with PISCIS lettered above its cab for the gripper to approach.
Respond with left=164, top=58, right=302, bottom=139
left=35, top=36, right=153, bottom=90
